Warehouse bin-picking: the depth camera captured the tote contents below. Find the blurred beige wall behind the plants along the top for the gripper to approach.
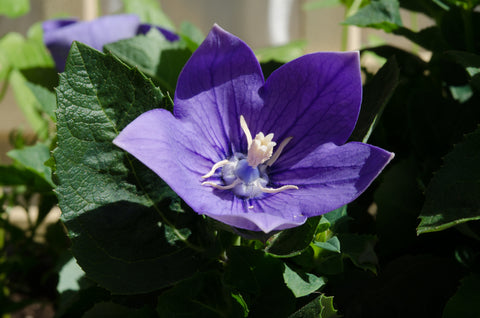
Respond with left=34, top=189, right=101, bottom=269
left=0, top=0, right=431, bottom=162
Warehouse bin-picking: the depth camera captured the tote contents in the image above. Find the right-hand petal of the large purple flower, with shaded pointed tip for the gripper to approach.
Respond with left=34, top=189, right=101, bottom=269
left=270, top=142, right=393, bottom=217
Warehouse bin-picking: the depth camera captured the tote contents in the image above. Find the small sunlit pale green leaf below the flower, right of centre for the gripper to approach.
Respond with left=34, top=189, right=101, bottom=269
left=283, top=264, right=326, bottom=298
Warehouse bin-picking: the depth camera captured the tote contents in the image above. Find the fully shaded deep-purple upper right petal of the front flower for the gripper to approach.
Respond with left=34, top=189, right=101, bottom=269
left=255, top=52, right=362, bottom=168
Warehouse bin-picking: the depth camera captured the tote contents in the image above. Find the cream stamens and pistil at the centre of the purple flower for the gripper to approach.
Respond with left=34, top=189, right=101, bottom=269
left=202, top=116, right=298, bottom=198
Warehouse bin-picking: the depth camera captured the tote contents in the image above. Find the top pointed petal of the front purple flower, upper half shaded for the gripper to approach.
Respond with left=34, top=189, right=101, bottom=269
left=174, top=25, right=263, bottom=159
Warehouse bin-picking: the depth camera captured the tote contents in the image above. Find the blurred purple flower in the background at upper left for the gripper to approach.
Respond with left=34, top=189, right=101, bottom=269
left=42, top=14, right=179, bottom=72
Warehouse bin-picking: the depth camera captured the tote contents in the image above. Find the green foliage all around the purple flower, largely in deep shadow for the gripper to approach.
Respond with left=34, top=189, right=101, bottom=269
left=0, top=0, right=480, bottom=318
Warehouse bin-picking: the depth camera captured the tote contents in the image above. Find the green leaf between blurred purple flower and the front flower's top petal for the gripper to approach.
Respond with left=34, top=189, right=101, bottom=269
left=104, top=29, right=191, bottom=96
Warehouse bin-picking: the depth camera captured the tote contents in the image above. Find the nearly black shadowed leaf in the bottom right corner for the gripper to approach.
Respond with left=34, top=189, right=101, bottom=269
left=442, top=274, right=480, bottom=318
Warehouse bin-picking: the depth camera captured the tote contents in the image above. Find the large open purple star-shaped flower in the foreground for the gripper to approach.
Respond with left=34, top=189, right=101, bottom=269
left=114, top=26, right=393, bottom=233
